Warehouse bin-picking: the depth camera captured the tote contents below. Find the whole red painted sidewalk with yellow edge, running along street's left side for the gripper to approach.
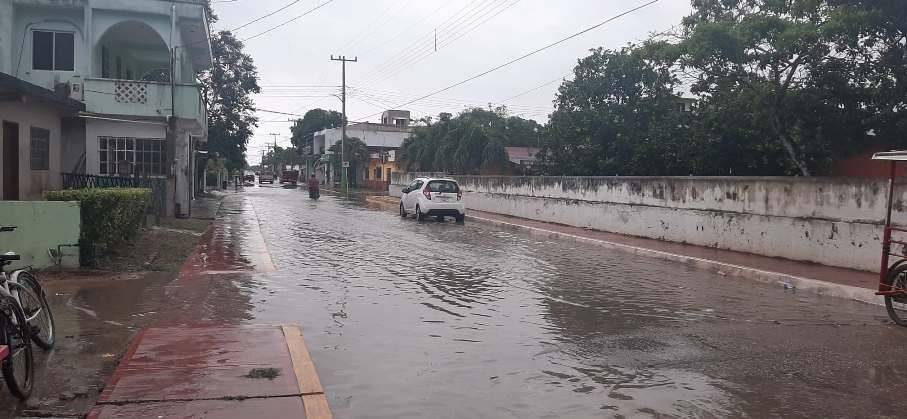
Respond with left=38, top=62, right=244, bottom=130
left=88, top=196, right=331, bottom=419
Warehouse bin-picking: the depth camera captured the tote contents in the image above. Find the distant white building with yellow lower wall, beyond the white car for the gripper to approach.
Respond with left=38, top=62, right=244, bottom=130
left=312, top=110, right=412, bottom=190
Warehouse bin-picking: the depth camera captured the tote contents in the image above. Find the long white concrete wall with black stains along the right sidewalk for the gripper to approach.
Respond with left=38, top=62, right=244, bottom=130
left=390, top=174, right=907, bottom=271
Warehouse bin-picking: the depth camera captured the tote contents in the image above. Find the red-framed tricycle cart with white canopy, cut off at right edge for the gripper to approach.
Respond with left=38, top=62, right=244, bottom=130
left=872, top=151, right=907, bottom=326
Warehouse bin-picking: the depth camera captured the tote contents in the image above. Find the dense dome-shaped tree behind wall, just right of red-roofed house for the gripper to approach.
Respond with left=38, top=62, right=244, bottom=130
left=540, top=45, right=694, bottom=175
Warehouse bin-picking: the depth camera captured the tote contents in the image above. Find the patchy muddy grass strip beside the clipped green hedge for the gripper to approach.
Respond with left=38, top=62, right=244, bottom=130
left=97, top=218, right=211, bottom=273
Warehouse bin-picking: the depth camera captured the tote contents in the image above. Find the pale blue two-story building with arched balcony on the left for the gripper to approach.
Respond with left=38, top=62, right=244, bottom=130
left=0, top=0, right=212, bottom=215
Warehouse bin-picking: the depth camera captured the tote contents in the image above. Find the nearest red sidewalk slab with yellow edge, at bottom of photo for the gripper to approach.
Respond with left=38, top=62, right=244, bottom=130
left=88, top=326, right=331, bottom=419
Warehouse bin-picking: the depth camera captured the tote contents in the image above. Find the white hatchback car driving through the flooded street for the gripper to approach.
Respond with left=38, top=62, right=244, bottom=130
left=400, top=177, right=466, bottom=223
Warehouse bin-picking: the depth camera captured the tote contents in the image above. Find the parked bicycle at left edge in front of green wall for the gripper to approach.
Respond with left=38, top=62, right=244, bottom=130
left=0, top=227, right=55, bottom=399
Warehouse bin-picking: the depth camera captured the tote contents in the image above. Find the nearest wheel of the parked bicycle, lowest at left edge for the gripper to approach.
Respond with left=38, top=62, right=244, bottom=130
left=0, top=297, right=35, bottom=400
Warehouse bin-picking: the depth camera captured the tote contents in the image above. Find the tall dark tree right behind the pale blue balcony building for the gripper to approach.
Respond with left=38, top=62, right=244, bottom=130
left=199, top=31, right=261, bottom=172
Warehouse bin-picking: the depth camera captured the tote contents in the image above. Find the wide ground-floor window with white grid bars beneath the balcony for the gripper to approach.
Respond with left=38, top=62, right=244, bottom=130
left=98, top=137, right=164, bottom=176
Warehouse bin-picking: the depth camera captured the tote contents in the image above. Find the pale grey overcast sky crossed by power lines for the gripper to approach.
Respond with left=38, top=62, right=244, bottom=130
left=212, top=0, right=690, bottom=164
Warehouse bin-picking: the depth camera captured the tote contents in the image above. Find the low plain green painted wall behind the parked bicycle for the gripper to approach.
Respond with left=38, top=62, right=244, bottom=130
left=0, top=201, right=80, bottom=268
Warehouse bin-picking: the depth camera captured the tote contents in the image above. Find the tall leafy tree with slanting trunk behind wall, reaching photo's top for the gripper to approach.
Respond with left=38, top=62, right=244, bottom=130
left=680, top=0, right=863, bottom=176
